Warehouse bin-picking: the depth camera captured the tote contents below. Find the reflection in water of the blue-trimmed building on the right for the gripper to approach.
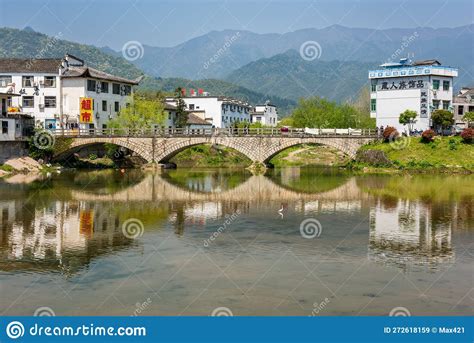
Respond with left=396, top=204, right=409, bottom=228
left=369, top=198, right=454, bottom=267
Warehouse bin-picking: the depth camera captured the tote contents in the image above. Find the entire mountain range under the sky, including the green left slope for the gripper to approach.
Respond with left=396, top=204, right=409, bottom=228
left=0, top=24, right=474, bottom=113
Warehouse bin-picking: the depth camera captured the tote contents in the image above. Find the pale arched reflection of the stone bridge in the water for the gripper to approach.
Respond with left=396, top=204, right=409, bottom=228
left=72, top=174, right=368, bottom=202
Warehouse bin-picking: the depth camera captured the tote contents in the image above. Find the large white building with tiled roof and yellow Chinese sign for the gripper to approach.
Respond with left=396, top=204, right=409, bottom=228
left=0, top=54, right=138, bottom=129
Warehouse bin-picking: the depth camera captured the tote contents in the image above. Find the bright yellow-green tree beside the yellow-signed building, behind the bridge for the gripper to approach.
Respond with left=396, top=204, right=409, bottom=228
left=108, top=95, right=165, bottom=133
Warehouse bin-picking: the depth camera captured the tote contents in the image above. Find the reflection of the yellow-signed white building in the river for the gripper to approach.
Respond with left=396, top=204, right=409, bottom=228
left=0, top=201, right=130, bottom=273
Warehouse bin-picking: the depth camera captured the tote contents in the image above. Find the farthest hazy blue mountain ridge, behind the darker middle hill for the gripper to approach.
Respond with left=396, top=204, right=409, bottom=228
left=104, top=24, right=474, bottom=84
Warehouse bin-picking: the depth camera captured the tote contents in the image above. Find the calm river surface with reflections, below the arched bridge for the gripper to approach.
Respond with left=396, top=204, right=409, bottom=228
left=0, top=168, right=474, bottom=316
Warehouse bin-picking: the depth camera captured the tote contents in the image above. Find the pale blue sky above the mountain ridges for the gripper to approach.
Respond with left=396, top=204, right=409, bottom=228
left=0, top=0, right=474, bottom=49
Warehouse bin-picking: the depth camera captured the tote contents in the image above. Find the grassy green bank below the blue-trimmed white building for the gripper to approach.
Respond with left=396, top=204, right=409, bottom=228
left=353, top=137, right=474, bottom=172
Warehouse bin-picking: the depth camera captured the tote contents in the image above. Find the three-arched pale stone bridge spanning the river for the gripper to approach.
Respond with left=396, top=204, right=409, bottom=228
left=55, top=129, right=377, bottom=164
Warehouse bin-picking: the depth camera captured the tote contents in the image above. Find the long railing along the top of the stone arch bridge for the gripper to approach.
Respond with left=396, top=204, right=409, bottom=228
left=50, top=127, right=378, bottom=138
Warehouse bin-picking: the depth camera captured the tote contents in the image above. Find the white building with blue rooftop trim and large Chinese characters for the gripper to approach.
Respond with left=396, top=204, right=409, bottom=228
left=369, top=58, right=458, bottom=132
